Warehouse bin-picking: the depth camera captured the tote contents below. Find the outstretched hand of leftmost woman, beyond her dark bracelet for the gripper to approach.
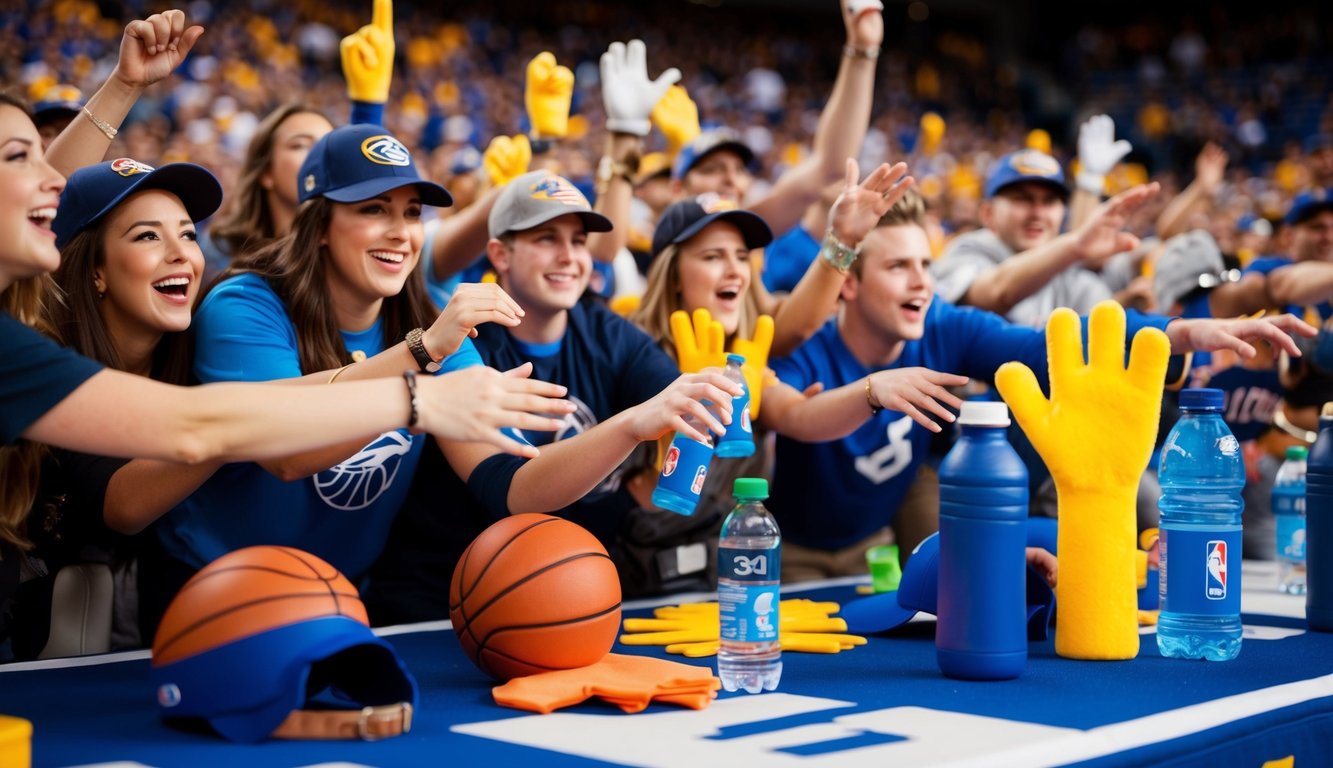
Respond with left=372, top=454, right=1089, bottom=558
left=417, top=364, right=575, bottom=459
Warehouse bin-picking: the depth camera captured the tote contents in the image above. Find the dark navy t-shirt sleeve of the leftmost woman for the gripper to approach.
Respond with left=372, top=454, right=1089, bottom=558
left=0, top=311, right=103, bottom=445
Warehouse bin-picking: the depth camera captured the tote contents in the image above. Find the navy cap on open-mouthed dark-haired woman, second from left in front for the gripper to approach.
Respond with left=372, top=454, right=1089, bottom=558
left=51, top=157, right=223, bottom=248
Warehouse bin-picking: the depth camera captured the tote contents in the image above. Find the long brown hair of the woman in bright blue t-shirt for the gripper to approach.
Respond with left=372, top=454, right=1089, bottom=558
left=221, top=197, right=440, bottom=373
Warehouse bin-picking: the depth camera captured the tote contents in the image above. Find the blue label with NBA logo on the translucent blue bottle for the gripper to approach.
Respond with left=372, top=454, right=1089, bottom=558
left=1160, top=525, right=1241, bottom=616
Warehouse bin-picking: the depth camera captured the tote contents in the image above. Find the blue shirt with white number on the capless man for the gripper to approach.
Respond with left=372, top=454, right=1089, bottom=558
left=766, top=296, right=1172, bottom=549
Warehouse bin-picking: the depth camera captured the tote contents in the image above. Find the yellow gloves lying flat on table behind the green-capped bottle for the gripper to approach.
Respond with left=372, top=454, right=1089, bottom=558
left=620, top=600, right=865, bottom=659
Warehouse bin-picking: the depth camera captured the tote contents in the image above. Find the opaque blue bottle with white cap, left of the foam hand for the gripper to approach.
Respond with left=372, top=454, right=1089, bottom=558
left=934, top=400, right=1028, bottom=680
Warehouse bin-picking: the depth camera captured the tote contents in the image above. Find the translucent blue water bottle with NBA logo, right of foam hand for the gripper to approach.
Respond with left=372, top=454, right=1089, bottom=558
left=1157, top=389, right=1245, bottom=661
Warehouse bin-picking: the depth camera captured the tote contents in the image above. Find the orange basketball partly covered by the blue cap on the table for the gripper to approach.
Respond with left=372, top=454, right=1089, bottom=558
left=153, top=547, right=369, bottom=665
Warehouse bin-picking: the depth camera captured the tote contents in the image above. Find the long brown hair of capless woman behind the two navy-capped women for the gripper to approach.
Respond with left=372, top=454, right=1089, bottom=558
left=208, top=103, right=327, bottom=256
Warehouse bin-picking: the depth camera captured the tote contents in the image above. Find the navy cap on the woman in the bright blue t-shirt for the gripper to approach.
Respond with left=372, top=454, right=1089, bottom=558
left=296, top=123, right=453, bottom=208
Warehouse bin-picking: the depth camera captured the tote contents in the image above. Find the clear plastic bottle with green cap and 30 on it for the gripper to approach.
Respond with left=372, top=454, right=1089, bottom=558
left=717, top=477, right=782, bottom=693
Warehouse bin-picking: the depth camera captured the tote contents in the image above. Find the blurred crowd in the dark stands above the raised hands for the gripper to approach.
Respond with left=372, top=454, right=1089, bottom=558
left=0, top=0, right=1333, bottom=242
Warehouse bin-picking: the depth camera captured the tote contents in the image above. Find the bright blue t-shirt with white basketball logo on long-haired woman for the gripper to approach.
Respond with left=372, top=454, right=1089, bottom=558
left=159, top=275, right=481, bottom=579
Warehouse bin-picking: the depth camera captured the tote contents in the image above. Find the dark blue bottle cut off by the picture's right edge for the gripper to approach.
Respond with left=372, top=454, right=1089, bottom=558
left=1305, top=403, right=1333, bottom=632
